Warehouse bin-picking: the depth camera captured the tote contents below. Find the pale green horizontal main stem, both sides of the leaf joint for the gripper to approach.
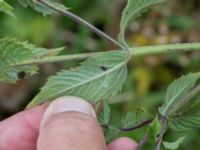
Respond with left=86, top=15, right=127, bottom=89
left=13, top=43, right=200, bottom=67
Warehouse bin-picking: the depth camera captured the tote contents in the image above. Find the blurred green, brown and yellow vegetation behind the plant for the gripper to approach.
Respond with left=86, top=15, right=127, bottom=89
left=0, top=0, right=200, bottom=150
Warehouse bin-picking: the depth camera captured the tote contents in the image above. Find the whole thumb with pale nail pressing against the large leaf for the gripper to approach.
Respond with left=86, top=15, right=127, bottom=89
left=37, top=97, right=106, bottom=150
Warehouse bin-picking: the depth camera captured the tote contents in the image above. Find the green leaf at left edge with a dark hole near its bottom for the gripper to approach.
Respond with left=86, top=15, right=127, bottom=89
left=0, top=38, right=62, bottom=83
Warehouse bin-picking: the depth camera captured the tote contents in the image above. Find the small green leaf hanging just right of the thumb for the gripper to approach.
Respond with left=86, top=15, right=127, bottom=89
left=98, top=102, right=110, bottom=125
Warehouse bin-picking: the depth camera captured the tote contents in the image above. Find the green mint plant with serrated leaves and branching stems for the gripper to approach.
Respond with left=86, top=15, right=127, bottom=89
left=0, top=0, right=200, bottom=150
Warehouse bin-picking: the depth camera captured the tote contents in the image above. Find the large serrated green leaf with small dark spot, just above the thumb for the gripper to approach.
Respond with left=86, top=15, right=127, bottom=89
left=28, top=51, right=128, bottom=107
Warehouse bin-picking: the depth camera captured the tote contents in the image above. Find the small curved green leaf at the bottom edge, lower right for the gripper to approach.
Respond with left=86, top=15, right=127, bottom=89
left=163, top=136, right=185, bottom=150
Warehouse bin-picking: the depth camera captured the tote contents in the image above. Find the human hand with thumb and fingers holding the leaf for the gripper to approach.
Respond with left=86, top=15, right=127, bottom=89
left=0, top=97, right=137, bottom=150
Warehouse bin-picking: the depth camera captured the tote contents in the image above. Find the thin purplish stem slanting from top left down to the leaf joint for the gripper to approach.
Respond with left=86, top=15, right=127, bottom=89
left=38, top=0, right=127, bottom=49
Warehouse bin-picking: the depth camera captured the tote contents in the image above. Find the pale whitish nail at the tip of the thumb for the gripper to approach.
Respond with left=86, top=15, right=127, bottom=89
left=40, top=96, right=96, bottom=126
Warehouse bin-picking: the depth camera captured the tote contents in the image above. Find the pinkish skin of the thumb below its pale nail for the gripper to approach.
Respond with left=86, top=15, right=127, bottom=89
left=37, top=111, right=106, bottom=150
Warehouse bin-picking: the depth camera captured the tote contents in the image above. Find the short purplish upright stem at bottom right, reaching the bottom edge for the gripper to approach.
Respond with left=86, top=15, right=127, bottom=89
left=155, top=116, right=168, bottom=150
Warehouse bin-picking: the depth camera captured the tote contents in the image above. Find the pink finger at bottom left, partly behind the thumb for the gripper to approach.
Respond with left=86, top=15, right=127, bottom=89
left=0, top=104, right=47, bottom=150
